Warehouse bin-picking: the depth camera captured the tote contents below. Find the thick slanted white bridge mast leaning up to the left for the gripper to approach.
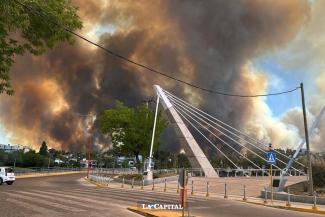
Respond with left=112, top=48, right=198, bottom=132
left=149, top=85, right=218, bottom=177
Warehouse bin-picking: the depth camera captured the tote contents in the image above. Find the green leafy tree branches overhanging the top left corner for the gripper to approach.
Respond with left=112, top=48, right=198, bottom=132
left=0, top=0, right=82, bottom=95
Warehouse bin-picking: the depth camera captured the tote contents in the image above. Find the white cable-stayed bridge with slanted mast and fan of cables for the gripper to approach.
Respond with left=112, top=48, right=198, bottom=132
left=154, top=85, right=325, bottom=190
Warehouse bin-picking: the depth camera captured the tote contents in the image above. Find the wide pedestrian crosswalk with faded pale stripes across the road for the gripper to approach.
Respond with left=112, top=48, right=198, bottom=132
left=4, top=186, right=202, bottom=217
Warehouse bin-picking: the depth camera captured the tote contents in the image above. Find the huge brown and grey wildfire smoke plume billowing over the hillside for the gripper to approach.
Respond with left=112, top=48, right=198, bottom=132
left=0, top=0, right=316, bottom=153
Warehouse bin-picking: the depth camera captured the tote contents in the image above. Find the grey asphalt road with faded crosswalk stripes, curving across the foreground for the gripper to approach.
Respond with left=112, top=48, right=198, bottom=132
left=0, top=174, right=322, bottom=217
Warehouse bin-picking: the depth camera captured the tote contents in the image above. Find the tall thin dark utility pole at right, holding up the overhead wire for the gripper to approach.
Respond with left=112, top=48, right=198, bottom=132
left=300, top=83, right=314, bottom=195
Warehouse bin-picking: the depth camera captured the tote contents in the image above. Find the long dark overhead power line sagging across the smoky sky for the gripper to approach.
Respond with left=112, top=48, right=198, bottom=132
left=13, top=0, right=300, bottom=98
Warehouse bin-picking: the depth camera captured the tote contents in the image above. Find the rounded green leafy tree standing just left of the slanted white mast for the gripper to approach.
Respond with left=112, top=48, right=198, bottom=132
left=100, top=101, right=166, bottom=170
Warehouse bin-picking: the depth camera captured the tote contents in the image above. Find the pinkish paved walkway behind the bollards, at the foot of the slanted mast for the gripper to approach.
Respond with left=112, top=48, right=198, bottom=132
left=90, top=177, right=325, bottom=214
